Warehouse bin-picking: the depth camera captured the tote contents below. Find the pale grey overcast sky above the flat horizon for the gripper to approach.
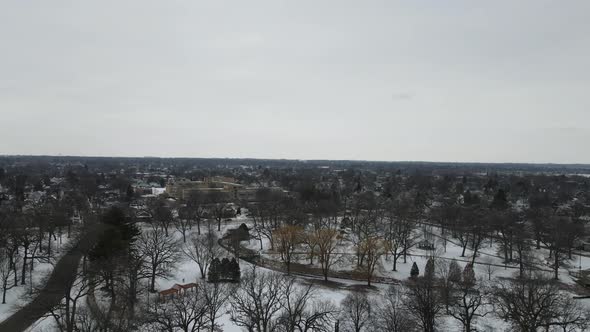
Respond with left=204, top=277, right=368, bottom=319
left=0, top=0, right=590, bottom=163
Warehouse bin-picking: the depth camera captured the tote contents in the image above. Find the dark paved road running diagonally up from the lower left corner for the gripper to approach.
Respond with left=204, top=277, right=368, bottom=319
left=0, top=225, right=101, bottom=332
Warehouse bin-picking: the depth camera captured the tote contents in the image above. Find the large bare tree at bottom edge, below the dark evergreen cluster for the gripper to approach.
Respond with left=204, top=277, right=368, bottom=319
left=230, top=268, right=285, bottom=332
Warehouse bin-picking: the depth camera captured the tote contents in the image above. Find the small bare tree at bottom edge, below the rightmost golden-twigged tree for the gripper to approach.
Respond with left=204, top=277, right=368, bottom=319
left=340, top=292, right=374, bottom=332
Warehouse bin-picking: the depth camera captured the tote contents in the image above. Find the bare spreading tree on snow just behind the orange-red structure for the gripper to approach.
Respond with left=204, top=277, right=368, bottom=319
left=138, top=228, right=179, bottom=292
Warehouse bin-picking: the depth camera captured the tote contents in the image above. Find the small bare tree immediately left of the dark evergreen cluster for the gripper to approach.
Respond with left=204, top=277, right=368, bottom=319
left=182, top=231, right=221, bottom=279
